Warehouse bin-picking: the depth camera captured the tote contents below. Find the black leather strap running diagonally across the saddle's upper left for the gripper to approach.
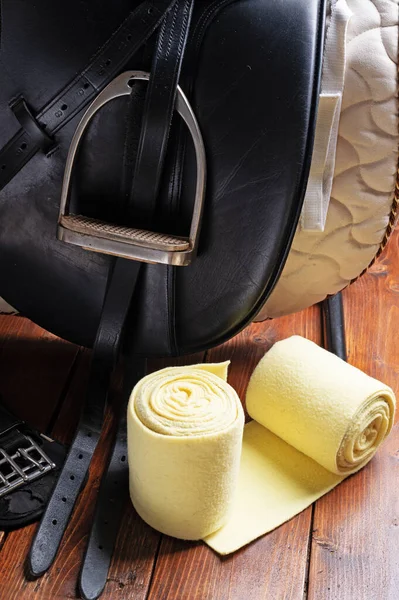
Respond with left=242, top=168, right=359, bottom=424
left=0, top=0, right=176, bottom=190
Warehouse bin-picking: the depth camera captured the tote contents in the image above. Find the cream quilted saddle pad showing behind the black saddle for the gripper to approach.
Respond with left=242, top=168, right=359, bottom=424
left=257, top=0, right=399, bottom=320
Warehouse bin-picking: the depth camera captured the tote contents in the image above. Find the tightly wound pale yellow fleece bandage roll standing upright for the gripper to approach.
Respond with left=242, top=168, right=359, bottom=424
left=128, top=362, right=244, bottom=540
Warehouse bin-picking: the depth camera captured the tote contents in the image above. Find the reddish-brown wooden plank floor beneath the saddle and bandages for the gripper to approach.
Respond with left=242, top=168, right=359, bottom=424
left=0, top=227, right=399, bottom=600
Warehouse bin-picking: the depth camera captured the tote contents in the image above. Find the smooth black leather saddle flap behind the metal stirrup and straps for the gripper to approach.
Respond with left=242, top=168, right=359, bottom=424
left=0, top=0, right=324, bottom=355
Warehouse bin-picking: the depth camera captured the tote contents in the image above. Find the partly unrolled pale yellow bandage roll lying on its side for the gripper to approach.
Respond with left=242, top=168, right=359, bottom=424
left=205, top=336, right=395, bottom=554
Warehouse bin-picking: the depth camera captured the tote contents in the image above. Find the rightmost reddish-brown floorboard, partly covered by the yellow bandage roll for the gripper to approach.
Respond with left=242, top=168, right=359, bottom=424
left=308, top=231, right=399, bottom=600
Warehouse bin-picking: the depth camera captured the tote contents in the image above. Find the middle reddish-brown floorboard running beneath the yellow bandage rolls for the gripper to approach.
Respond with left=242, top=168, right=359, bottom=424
left=149, top=308, right=321, bottom=600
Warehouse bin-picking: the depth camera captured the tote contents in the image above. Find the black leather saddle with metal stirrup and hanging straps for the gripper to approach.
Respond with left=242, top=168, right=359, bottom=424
left=0, top=0, right=325, bottom=598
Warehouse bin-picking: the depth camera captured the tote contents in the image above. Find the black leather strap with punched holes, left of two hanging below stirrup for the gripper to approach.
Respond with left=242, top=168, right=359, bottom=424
left=28, top=259, right=140, bottom=576
